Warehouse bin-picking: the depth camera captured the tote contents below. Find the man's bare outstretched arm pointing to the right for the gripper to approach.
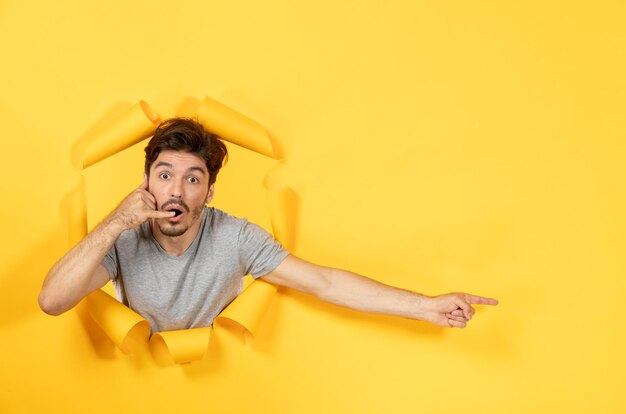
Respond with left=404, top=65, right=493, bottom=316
left=263, top=255, right=498, bottom=328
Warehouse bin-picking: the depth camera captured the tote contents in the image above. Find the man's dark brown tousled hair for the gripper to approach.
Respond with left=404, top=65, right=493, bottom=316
left=144, top=118, right=228, bottom=185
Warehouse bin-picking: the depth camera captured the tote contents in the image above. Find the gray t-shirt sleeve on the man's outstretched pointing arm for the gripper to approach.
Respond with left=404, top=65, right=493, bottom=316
left=238, top=221, right=289, bottom=279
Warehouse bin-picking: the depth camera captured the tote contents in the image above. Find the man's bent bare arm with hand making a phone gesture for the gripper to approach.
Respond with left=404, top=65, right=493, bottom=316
left=39, top=177, right=174, bottom=315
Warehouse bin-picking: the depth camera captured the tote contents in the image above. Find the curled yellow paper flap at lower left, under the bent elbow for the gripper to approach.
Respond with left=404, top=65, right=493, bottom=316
left=87, top=289, right=150, bottom=354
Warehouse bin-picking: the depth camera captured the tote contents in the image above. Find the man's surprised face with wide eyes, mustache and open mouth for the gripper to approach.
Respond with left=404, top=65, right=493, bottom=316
left=148, top=150, right=213, bottom=237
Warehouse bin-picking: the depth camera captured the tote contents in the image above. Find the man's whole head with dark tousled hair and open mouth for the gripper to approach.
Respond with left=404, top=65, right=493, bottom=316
left=145, top=118, right=227, bottom=237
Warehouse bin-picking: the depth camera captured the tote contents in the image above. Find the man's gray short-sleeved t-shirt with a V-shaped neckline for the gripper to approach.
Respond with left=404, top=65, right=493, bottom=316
left=102, top=208, right=289, bottom=332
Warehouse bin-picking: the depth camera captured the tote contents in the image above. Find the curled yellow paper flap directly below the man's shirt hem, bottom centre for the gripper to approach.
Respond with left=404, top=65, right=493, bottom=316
left=150, top=327, right=213, bottom=365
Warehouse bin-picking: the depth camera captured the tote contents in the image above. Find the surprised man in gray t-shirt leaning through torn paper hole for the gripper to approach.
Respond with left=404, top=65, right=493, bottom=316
left=39, top=118, right=497, bottom=332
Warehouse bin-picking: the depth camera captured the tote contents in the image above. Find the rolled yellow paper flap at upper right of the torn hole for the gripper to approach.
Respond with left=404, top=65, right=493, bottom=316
left=197, top=96, right=278, bottom=159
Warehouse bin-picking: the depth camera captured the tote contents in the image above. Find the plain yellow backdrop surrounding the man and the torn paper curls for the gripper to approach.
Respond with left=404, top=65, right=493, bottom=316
left=0, top=0, right=626, bottom=413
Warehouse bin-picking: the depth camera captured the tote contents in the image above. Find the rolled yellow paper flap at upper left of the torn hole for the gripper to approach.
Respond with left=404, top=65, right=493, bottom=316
left=83, top=101, right=160, bottom=168
